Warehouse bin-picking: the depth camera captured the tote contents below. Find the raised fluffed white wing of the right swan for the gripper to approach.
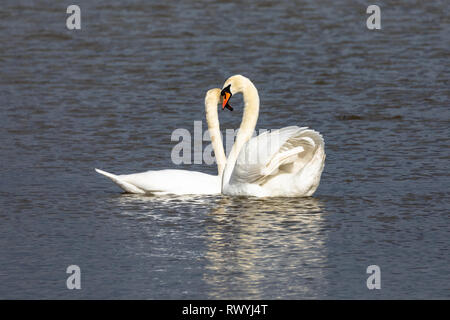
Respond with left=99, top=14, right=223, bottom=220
left=231, top=126, right=324, bottom=185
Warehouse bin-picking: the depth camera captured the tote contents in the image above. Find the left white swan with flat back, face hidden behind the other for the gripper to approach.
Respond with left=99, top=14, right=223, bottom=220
left=95, top=88, right=226, bottom=195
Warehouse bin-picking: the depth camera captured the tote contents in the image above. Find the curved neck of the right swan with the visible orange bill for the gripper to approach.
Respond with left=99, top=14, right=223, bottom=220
left=222, top=77, right=259, bottom=190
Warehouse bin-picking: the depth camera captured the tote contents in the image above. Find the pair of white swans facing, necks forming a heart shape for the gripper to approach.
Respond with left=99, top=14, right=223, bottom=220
left=95, top=75, right=325, bottom=197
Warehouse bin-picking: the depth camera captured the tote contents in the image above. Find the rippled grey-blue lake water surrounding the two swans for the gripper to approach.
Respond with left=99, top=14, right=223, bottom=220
left=0, top=0, right=450, bottom=299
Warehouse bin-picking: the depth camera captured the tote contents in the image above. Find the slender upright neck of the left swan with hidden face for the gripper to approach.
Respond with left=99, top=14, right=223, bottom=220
left=205, top=89, right=227, bottom=176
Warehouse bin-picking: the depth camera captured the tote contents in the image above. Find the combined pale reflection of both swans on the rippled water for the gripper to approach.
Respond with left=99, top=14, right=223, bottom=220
left=109, top=194, right=328, bottom=299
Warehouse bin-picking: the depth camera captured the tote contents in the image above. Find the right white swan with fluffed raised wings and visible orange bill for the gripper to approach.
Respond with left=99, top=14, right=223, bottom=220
left=221, top=75, right=325, bottom=197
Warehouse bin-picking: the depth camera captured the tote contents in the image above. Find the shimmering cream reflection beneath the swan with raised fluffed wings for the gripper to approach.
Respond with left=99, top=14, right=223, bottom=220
left=204, top=198, right=326, bottom=299
